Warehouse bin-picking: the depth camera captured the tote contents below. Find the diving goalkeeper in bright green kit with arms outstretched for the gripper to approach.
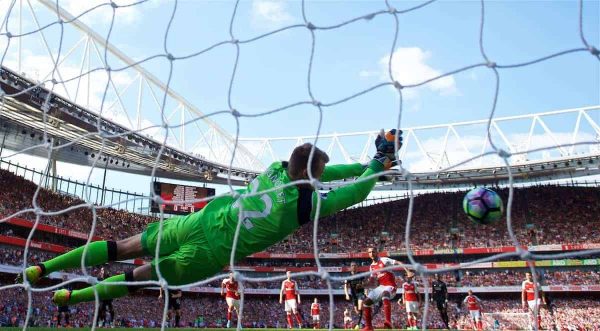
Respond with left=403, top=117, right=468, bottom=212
left=19, top=130, right=402, bottom=306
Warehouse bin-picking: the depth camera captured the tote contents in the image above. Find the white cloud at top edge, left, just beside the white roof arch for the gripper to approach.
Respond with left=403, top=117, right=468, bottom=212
left=60, top=0, right=142, bottom=24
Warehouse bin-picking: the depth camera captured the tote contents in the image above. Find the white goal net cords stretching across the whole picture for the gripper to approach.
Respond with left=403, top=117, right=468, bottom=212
left=0, top=0, right=600, bottom=330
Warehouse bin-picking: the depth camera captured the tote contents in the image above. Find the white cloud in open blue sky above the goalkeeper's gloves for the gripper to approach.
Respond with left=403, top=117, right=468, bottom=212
left=378, top=47, right=458, bottom=98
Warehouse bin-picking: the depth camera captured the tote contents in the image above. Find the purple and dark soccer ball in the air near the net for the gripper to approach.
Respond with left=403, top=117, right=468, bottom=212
left=463, top=187, right=504, bottom=224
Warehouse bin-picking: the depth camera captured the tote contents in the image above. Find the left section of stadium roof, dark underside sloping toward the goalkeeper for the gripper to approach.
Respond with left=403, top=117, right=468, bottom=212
left=0, top=68, right=252, bottom=185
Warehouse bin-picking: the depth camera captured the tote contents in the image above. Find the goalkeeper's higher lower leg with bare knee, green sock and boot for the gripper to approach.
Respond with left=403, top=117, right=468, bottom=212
left=25, top=234, right=144, bottom=284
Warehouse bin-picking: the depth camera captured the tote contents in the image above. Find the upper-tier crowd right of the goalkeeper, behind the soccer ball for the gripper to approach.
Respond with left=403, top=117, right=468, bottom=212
left=269, top=186, right=600, bottom=252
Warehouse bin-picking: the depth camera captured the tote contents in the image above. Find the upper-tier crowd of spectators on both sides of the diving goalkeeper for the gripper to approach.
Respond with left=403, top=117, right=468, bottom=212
left=0, top=169, right=600, bottom=253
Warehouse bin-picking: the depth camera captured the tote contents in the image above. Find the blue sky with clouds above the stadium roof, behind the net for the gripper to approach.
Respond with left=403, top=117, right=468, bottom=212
left=0, top=0, right=600, bottom=202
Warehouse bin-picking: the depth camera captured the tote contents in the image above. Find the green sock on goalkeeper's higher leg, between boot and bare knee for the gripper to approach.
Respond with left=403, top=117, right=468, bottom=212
left=40, top=241, right=117, bottom=275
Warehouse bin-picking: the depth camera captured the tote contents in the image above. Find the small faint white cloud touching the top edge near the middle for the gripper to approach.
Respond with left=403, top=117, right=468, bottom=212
left=251, top=0, right=293, bottom=29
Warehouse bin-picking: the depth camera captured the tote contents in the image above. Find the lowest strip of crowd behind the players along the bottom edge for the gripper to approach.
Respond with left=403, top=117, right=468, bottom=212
left=0, top=289, right=600, bottom=330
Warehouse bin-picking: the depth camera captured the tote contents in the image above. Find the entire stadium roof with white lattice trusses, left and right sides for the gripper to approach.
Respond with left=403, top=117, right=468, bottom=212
left=0, top=0, right=600, bottom=190
